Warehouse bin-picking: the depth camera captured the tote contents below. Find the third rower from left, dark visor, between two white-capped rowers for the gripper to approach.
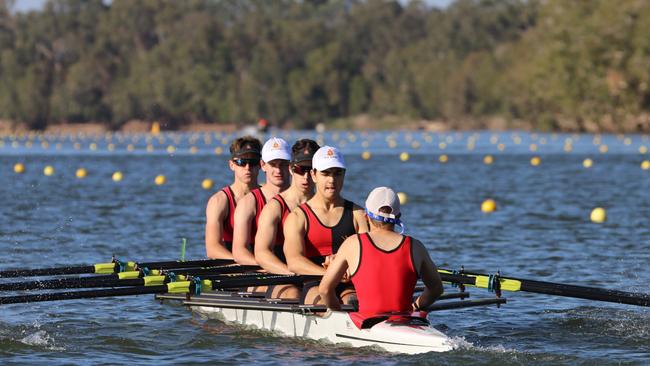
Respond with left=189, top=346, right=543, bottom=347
left=255, top=139, right=319, bottom=298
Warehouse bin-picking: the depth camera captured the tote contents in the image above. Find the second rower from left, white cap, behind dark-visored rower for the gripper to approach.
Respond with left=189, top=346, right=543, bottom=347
left=232, top=137, right=291, bottom=265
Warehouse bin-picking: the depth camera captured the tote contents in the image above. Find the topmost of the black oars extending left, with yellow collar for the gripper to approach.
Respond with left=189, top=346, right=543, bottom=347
left=0, top=259, right=233, bottom=278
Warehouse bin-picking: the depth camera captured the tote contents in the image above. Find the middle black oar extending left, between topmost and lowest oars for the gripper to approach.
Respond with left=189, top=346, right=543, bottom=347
left=0, top=265, right=260, bottom=291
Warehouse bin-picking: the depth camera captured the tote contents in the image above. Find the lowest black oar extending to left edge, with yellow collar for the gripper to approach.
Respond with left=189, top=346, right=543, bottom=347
left=0, top=274, right=321, bottom=305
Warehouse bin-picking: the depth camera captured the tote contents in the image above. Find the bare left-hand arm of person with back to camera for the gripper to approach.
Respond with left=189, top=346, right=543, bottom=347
left=318, top=235, right=359, bottom=310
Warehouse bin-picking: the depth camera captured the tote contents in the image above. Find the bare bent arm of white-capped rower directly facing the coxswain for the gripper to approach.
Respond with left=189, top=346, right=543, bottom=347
left=284, top=208, right=325, bottom=275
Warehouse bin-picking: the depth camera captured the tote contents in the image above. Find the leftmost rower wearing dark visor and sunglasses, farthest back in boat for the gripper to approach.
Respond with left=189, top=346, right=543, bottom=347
left=205, top=136, right=262, bottom=259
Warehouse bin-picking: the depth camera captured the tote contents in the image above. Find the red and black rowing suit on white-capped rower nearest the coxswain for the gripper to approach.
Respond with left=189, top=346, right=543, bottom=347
left=298, top=200, right=356, bottom=264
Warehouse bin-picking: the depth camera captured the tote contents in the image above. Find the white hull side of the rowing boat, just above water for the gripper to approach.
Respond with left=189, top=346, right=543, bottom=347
left=191, top=300, right=454, bottom=354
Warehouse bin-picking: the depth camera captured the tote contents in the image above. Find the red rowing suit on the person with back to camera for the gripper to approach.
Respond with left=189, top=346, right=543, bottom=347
left=350, top=233, right=418, bottom=327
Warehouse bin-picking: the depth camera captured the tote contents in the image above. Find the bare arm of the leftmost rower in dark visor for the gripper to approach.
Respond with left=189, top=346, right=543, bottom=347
left=205, top=191, right=233, bottom=259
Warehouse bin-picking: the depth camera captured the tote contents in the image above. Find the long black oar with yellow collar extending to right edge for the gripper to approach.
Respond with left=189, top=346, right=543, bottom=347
left=438, top=269, right=650, bottom=306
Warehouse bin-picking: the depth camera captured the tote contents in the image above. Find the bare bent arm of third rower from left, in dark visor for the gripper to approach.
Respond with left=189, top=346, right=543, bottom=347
left=255, top=200, right=291, bottom=274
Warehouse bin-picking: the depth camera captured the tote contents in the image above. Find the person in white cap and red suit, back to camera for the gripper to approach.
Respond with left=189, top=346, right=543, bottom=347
left=319, top=187, right=443, bottom=326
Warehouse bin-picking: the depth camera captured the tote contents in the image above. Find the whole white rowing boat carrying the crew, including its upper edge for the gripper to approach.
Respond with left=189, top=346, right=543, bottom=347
left=157, top=292, right=455, bottom=354
